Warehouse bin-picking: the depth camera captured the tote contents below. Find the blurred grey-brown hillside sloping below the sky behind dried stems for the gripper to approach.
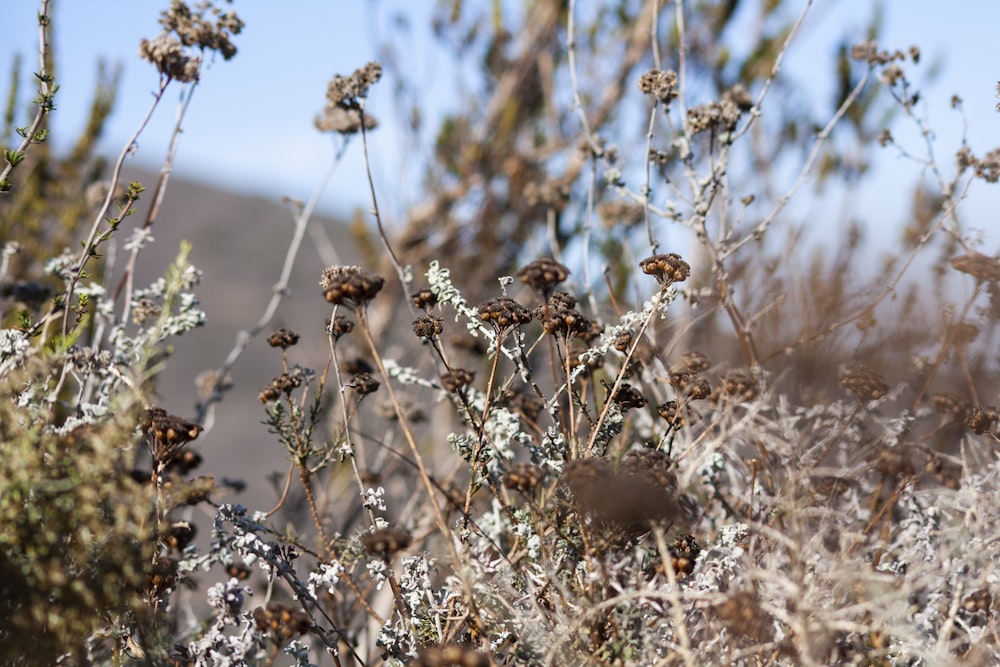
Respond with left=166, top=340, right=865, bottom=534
left=123, top=169, right=358, bottom=510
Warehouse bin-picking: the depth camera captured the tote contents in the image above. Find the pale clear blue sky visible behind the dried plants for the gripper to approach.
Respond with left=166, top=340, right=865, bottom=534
left=0, top=0, right=1000, bottom=240
